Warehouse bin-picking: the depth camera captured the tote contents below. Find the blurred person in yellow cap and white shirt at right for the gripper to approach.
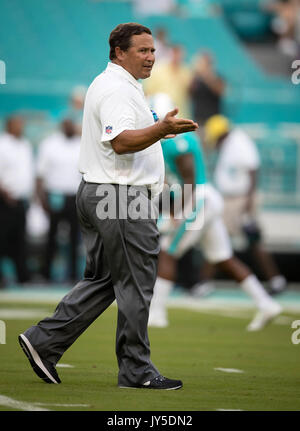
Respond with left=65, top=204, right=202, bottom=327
left=204, top=115, right=286, bottom=294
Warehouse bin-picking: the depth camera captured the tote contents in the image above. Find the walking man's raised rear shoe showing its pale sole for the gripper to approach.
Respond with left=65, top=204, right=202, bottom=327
left=19, top=334, right=61, bottom=384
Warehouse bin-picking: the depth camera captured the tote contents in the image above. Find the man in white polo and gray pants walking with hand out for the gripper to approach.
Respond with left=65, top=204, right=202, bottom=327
left=19, top=23, right=198, bottom=390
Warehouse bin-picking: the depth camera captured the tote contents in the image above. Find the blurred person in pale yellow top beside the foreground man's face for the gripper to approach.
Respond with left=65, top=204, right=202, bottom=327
left=144, top=45, right=191, bottom=118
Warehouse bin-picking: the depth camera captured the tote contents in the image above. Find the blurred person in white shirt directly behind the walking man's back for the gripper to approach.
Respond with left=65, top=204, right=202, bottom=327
left=36, top=118, right=81, bottom=281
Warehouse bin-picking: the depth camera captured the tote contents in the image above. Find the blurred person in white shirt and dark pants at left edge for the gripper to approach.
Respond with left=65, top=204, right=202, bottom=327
left=0, top=116, right=34, bottom=283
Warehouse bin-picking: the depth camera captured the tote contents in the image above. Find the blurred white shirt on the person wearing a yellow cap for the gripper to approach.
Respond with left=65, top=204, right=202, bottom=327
left=214, top=129, right=260, bottom=197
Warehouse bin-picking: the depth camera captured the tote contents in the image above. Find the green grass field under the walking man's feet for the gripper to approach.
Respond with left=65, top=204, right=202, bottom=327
left=0, top=288, right=300, bottom=411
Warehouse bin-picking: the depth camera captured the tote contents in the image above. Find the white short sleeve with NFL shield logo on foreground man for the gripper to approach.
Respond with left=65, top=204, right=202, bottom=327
left=99, top=88, right=136, bottom=142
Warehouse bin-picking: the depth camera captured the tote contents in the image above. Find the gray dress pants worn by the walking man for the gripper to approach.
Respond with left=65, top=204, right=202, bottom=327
left=24, top=181, right=160, bottom=385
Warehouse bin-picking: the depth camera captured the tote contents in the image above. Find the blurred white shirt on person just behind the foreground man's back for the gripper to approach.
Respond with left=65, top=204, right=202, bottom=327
left=36, top=132, right=81, bottom=195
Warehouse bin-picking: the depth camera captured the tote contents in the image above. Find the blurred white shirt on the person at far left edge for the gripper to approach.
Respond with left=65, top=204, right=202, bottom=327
left=0, top=133, right=34, bottom=199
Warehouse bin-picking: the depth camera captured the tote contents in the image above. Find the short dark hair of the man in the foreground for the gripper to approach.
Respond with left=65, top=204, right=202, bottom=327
left=109, top=22, right=152, bottom=60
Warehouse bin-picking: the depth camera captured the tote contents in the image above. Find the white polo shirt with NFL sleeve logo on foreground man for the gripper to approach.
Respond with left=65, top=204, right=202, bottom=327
left=79, top=63, right=164, bottom=195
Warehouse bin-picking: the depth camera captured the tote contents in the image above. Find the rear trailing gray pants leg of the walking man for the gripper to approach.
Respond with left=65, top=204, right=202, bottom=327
left=24, top=183, right=115, bottom=364
